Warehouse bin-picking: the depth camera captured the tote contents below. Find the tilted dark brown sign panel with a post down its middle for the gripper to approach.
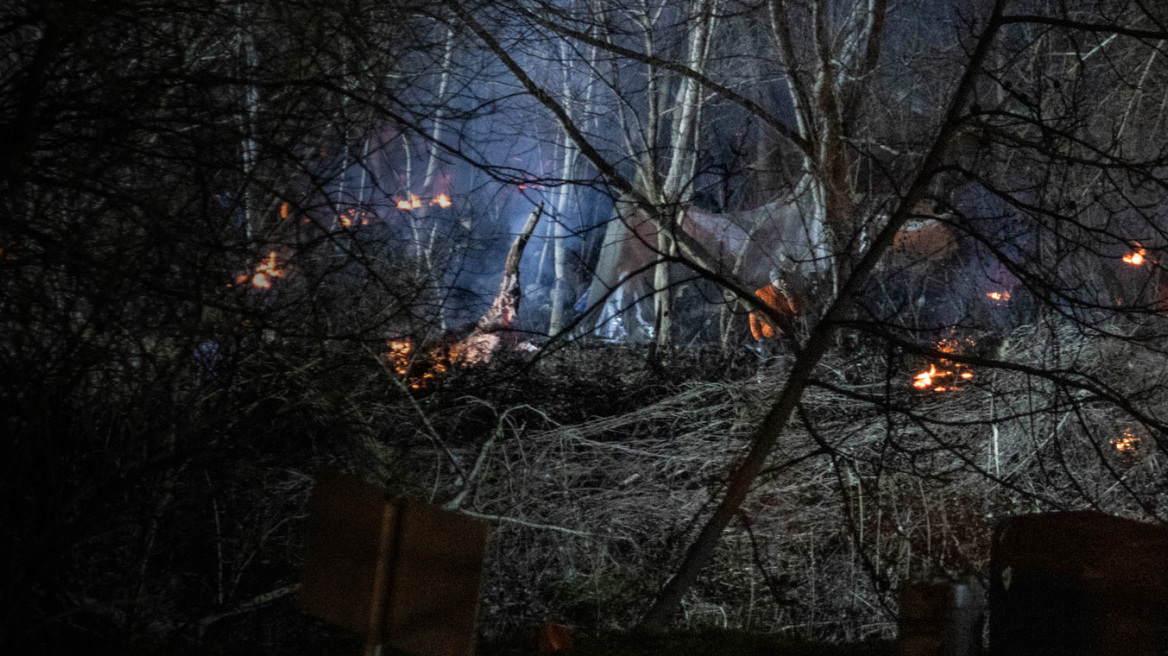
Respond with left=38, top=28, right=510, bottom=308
left=300, top=474, right=487, bottom=656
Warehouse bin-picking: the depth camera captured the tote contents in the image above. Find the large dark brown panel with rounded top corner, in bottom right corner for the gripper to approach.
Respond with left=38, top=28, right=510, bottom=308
left=989, top=512, right=1168, bottom=656
